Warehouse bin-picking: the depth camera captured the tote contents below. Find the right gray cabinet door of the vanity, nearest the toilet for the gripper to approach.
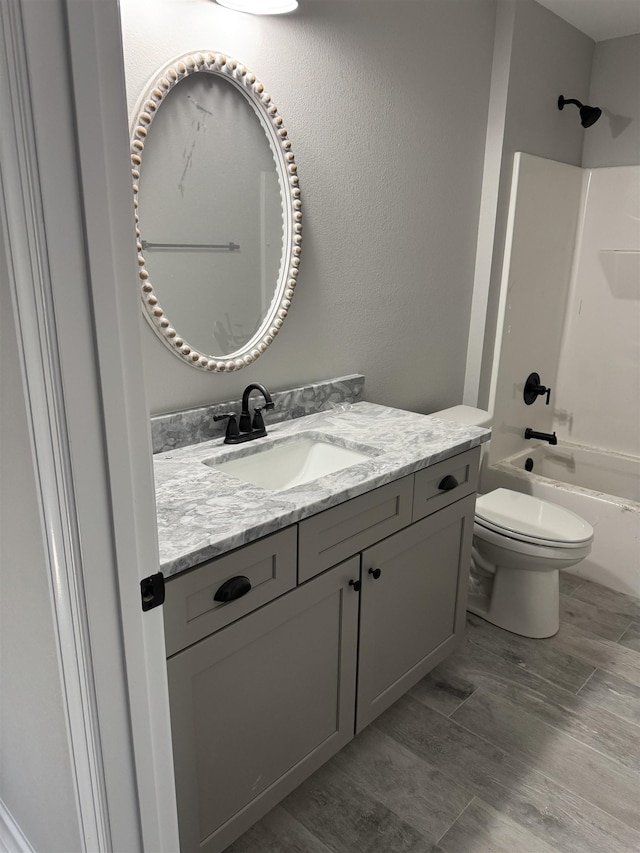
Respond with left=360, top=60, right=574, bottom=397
left=356, top=495, right=475, bottom=732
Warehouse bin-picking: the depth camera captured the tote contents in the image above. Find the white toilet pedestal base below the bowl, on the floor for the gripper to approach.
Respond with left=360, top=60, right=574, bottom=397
left=467, top=566, right=560, bottom=640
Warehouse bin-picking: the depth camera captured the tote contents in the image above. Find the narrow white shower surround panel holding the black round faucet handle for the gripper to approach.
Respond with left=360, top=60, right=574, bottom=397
left=491, top=154, right=583, bottom=461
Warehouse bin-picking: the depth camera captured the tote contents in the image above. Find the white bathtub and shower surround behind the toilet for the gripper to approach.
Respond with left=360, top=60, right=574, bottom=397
left=481, top=154, right=640, bottom=595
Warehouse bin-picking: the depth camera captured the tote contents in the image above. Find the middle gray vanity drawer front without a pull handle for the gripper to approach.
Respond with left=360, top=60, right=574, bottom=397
left=298, top=474, right=413, bottom=583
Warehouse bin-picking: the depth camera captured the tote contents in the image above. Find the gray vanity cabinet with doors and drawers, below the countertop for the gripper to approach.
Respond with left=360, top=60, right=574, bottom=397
left=165, top=448, right=479, bottom=853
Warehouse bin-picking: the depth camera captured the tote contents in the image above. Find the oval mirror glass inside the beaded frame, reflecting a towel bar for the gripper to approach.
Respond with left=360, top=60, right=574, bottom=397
left=138, top=74, right=283, bottom=355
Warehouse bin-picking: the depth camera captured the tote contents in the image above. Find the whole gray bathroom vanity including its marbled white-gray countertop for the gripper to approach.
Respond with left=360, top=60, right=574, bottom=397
left=155, top=403, right=489, bottom=853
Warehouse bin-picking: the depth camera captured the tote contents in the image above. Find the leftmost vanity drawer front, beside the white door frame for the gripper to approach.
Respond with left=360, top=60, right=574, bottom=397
left=164, top=526, right=296, bottom=657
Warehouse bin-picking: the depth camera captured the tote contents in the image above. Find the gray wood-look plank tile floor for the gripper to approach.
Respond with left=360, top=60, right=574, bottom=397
left=228, top=573, right=640, bottom=853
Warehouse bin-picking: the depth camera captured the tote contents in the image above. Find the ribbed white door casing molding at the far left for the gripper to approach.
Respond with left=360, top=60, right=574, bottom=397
left=0, top=0, right=112, bottom=851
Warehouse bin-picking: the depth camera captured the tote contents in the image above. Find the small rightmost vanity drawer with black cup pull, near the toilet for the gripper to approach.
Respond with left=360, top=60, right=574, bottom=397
left=413, top=447, right=480, bottom=521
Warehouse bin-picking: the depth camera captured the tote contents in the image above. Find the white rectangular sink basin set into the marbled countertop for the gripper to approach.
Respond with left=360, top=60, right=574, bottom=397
left=205, top=438, right=378, bottom=492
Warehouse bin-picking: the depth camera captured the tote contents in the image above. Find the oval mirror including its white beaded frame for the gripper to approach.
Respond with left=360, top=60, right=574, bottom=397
left=131, top=52, right=302, bottom=372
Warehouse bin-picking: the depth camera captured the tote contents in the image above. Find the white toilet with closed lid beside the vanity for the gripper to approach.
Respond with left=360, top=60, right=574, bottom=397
left=433, top=406, right=593, bottom=639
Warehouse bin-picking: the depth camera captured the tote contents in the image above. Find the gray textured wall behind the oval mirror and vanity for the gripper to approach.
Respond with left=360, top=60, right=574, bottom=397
left=121, top=0, right=495, bottom=414
